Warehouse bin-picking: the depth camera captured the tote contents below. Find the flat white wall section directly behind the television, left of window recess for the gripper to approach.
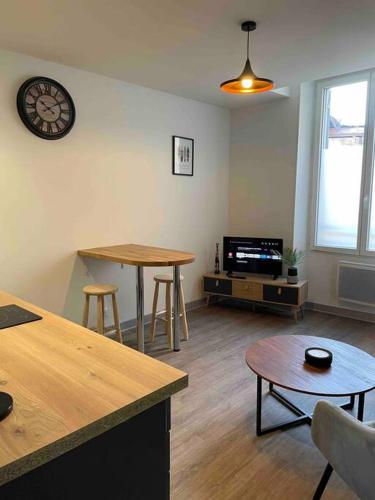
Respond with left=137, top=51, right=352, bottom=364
left=229, top=87, right=299, bottom=249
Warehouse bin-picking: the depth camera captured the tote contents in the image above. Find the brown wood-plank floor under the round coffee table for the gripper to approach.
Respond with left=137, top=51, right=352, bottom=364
left=131, top=305, right=375, bottom=500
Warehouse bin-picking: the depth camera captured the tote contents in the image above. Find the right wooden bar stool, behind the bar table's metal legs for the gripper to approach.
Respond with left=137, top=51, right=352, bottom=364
left=151, top=274, right=189, bottom=349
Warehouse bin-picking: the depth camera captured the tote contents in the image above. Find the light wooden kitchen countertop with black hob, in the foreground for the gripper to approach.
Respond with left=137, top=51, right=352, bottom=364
left=0, top=292, right=188, bottom=485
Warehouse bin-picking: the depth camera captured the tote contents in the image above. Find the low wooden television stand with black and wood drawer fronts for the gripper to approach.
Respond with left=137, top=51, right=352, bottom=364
left=203, top=273, right=308, bottom=320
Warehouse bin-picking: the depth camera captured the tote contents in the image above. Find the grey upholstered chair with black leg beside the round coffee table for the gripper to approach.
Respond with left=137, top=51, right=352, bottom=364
left=311, top=401, right=375, bottom=500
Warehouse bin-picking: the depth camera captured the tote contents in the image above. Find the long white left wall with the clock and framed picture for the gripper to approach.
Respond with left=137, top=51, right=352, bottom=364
left=0, top=51, right=230, bottom=321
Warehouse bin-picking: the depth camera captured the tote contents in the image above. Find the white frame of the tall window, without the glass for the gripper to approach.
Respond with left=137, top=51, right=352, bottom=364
left=310, top=70, right=375, bottom=257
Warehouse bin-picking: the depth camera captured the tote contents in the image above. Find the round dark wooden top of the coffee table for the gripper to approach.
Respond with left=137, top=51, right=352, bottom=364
left=246, top=335, right=375, bottom=396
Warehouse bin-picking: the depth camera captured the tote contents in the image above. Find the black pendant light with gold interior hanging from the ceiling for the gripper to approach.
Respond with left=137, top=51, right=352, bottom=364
left=220, top=21, right=273, bottom=94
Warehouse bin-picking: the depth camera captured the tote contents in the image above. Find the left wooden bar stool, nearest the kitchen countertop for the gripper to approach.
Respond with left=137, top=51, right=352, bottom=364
left=82, top=283, right=122, bottom=344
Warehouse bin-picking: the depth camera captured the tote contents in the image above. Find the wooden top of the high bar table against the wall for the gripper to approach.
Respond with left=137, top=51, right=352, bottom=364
left=78, top=244, right=195, bottom=267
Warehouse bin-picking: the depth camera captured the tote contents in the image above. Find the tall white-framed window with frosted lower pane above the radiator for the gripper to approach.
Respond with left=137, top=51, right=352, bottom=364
left=313, top=72, right=375, bottom=254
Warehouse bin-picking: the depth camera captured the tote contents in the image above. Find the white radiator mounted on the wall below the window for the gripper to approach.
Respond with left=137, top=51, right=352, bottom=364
left=337, top=261, right=375, bottom=306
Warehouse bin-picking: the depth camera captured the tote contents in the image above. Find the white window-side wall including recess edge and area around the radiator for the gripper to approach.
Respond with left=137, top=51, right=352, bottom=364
left=229, top=77, right=375, bottom=312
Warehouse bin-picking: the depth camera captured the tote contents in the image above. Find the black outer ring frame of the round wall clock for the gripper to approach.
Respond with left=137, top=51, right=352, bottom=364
left=17, top=76, right=76, bottom=141
